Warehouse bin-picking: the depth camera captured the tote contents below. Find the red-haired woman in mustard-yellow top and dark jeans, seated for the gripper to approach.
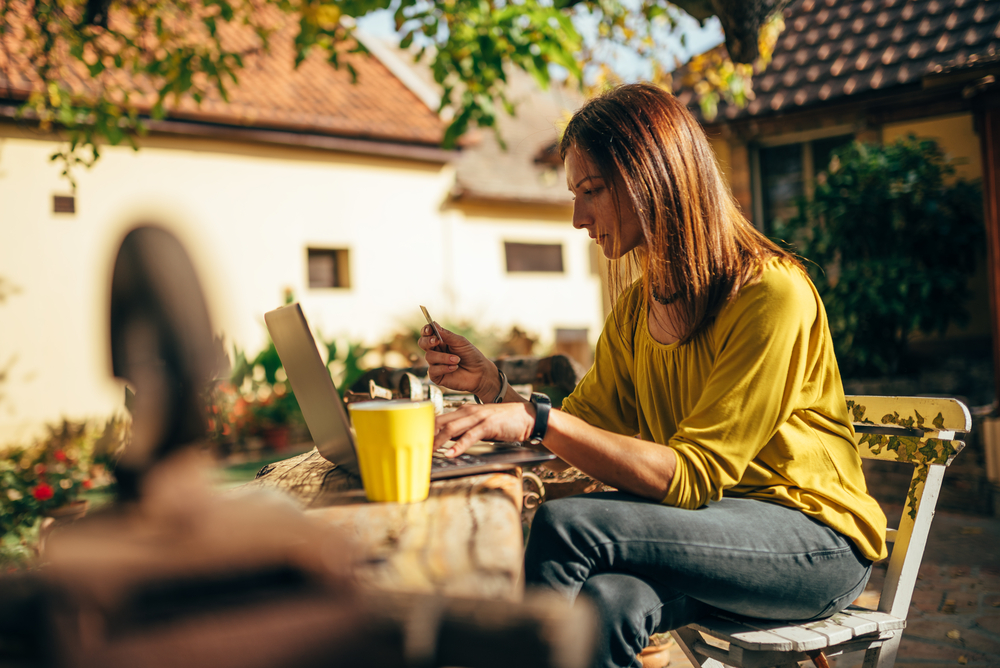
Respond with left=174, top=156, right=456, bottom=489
left=420, top=85, right=886, bottom=666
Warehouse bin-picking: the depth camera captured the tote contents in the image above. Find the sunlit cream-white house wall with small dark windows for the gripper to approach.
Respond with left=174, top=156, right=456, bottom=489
left=0, top=126, right=602, bottom=445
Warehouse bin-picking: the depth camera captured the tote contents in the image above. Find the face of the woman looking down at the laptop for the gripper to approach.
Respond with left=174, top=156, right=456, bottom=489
left=566, top=147, right=646, bottom=260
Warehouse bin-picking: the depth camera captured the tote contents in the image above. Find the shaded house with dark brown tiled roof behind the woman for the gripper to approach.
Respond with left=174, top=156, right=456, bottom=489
left=674, top=0, right=1000, bottom=506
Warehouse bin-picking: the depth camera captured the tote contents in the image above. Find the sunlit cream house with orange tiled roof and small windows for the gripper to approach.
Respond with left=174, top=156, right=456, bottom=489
left=0, top=14, right=604, bottom=443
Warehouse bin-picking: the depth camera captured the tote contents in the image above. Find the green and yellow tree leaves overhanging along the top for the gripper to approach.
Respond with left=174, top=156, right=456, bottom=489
left=0, top=0, right=780, bottom=181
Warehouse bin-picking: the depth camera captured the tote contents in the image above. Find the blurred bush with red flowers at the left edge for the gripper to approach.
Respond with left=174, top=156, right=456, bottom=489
left=0, top=418, right=129, bottom=536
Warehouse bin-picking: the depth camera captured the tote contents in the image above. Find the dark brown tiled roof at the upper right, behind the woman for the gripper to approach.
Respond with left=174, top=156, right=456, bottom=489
left=674, top=0, right=1000, bottom=121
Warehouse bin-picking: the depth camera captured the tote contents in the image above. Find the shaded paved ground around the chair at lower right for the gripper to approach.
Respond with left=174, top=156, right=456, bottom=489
left=656, top=507, right=1000, bottom=668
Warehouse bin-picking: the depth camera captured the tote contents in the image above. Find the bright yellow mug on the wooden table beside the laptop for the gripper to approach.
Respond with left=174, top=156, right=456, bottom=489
left=347, top=400, right=434, bottom=503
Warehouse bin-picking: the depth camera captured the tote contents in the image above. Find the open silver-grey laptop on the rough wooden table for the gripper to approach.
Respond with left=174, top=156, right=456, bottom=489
left=264, top=303, right=556, bottom=480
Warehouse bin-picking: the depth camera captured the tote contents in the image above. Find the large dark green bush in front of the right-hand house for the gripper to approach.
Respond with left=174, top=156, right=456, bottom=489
left=776, top=136, right=984, bottom=376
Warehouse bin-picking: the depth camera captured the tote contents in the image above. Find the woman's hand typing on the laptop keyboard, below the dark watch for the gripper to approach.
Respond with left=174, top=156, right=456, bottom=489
left=434, top=401, right=535, bottom=457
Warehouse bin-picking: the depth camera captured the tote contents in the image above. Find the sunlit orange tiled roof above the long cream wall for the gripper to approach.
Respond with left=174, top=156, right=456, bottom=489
left=0, top=6, right=444, bottom=146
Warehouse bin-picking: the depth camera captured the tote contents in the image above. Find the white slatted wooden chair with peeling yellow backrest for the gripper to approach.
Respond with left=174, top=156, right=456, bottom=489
left=671, top=396, right=972, bottom=668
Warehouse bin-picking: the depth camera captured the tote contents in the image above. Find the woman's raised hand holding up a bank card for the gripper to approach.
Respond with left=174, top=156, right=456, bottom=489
left=417, top=323, right=500, bottom=400
